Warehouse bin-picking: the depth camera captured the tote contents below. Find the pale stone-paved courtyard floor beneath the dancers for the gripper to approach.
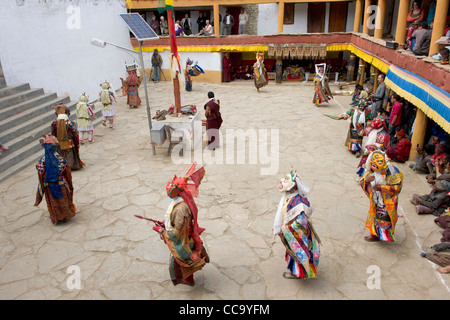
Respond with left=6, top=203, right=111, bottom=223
left=0, top=78, right=450, bottom=300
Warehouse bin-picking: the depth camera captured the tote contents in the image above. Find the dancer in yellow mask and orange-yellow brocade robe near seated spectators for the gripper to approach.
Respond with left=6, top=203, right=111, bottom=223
left=360, top=150, right=403, bottom=241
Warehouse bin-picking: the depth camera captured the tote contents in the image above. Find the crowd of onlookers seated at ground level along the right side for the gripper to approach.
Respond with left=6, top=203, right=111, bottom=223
left=352, top=75, right=450, bottom=273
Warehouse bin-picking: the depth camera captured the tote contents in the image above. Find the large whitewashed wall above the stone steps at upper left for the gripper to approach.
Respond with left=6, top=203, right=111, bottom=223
left=0, top=0, right=133, bottom=100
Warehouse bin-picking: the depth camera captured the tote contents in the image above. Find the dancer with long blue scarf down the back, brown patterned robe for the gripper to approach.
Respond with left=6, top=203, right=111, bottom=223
left=34, top=135, right=76, bottom=224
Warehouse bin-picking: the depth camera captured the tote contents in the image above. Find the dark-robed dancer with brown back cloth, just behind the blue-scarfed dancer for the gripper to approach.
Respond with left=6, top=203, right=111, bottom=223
left=51, top=103, right=83, bottom=171
